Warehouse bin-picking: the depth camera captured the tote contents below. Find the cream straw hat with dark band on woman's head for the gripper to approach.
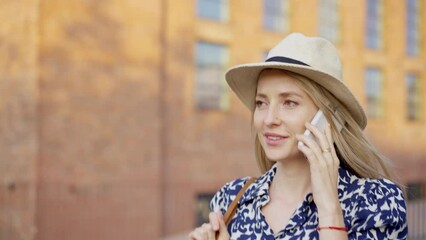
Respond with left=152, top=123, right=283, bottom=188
left=226, top=33, right=367, bottom=129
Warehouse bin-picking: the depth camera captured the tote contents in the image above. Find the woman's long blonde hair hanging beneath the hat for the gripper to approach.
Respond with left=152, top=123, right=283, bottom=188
left=252, top=69, right=395, bottom=181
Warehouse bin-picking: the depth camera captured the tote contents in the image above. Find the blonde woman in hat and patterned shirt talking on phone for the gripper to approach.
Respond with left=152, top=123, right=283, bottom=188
left=189, top=33, right=407, bottom=239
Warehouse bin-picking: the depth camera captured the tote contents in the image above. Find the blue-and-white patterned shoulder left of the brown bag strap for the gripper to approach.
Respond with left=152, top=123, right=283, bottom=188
left=210, top=177, right=250, bottom=213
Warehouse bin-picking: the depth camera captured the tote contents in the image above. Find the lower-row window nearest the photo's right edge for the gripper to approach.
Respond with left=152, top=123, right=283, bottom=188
left=405, top=73, right=421, bottom=120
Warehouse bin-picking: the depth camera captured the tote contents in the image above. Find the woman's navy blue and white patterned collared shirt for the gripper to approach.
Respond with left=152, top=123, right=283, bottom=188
left=210, top=166, right=407, bottom=240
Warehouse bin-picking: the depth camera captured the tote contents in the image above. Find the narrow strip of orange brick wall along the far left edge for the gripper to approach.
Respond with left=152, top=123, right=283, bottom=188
left=0, top=0, right=38, bottom=240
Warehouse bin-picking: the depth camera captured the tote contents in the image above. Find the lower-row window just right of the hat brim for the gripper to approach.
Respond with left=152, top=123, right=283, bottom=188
left=365, top=68, right=383, bottom=118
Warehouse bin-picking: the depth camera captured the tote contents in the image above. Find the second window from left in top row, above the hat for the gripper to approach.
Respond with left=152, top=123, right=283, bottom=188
left=263, top=0, right=290, bottom=33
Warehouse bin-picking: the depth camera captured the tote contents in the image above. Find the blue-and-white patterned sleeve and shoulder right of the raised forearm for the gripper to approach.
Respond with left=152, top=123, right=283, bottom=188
left=339, top=169, right=407, bottom=239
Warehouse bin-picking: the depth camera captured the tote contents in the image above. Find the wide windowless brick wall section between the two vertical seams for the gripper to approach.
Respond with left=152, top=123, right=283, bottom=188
left=36, top=0, right=162, bottom=240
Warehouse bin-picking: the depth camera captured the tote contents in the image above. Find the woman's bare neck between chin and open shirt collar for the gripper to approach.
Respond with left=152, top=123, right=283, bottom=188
left=270, top=158, right=311, bottom=202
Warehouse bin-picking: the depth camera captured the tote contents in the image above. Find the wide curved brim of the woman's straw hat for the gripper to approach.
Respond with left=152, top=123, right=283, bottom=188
left=225, top=62, right=367, bottom=129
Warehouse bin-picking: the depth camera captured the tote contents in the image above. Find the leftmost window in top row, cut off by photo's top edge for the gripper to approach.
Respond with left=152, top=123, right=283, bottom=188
left=197, top=0, right=229, bottom=22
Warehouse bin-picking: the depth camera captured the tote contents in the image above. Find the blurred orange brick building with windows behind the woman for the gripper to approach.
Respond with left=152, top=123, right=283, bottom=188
left=0, top=0, right=426, bottom=240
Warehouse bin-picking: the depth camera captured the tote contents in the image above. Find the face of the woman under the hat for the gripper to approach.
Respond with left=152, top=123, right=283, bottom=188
left=253, top=70, right=318, bottom=161
